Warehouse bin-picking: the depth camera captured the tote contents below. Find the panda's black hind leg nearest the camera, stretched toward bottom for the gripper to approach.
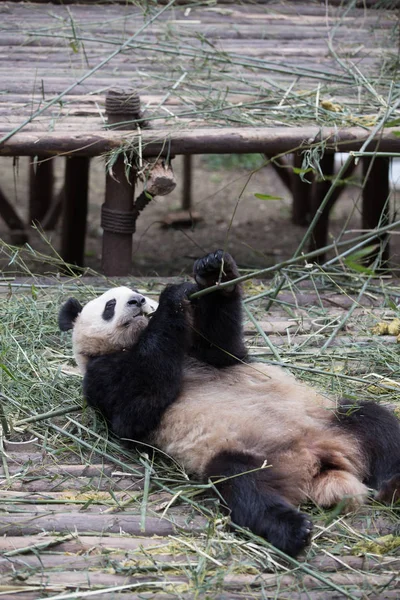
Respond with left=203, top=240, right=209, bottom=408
left=205, top=451, right=312, bottom=556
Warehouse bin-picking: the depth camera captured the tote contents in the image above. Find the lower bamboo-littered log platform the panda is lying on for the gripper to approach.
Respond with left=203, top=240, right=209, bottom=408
left=0, top=276, right=400, bottom=600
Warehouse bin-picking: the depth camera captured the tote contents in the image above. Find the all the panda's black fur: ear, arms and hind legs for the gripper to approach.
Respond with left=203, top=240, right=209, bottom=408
left=66, top=250, right=400, bottom=556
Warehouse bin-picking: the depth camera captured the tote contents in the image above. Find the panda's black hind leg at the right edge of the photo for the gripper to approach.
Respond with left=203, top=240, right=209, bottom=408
left=337, top=400, right=400, bottom=502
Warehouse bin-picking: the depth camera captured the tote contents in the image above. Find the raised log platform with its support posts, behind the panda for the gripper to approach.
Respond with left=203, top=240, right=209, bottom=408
left=0, top=0, right=400, bottom=275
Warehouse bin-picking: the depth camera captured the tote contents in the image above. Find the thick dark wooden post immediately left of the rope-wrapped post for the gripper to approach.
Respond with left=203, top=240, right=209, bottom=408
left=61, top=156, right=89, bottom=266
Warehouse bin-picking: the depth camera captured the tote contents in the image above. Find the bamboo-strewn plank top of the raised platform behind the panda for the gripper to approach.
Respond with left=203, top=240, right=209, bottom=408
left=0, top=1, right=398, bottom=151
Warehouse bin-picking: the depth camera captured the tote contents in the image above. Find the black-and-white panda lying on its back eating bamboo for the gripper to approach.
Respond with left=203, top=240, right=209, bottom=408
left=59, top=251, right=400, bottom=556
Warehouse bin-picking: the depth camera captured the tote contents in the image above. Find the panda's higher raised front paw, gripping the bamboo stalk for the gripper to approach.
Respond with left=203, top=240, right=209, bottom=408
left=193, top=250, right=239, bottom=288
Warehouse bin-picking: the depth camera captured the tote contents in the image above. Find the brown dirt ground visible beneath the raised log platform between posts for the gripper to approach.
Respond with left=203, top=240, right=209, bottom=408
left=0, top=155, right=400, bottom=276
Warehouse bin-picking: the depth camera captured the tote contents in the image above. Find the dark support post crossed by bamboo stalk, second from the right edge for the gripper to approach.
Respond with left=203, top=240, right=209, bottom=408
left=310, top=152, right=337, bottom=263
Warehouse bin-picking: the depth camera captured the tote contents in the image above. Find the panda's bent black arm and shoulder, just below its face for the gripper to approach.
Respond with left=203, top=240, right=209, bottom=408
left=83, top=283, right=197, bottom=440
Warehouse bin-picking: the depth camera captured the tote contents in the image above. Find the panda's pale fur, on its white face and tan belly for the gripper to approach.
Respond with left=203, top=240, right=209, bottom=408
left=73, top=287, right=367, bottom=506
